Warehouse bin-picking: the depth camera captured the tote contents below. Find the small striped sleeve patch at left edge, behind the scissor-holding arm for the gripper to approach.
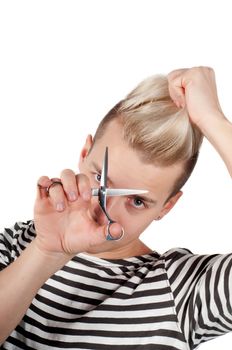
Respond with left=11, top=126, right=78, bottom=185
left=0, top=220, right=36, bottom=270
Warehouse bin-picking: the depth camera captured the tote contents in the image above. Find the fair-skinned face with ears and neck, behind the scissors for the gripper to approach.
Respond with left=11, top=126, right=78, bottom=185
left=76, top=121, right=182, bottom=259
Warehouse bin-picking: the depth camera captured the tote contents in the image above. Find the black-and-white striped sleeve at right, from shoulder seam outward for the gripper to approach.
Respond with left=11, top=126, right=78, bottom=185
left=164, top=250, right=232, bottom=349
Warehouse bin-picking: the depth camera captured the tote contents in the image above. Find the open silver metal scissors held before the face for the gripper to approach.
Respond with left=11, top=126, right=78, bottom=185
left=92, top=147, right=148, bottom=241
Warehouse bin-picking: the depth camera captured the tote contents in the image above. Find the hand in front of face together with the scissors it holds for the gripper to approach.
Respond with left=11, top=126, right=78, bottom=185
left=37, top=148, right=147, bottom=253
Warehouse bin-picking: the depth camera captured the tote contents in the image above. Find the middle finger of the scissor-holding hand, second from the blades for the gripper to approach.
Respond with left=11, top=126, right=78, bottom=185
left=60, top=169, right=78, bottom=202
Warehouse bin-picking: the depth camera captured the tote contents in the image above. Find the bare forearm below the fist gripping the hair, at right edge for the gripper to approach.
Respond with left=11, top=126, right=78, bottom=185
left=200, top=115, right=232, bottom=177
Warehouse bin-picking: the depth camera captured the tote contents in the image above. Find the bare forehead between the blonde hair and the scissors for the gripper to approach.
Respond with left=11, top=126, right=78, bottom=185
left=88, top=123, right=181, bottom=200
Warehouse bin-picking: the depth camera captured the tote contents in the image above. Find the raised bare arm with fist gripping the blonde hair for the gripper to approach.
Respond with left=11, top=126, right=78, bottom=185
left=168, top=67, right=232, bottom=177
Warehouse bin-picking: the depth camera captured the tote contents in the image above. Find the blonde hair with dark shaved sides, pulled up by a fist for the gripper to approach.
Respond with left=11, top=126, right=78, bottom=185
left=94, top=75, right=203, bottom=199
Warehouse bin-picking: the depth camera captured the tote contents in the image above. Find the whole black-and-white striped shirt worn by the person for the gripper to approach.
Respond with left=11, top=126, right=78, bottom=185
left=0, top=220, right=232, bottom=350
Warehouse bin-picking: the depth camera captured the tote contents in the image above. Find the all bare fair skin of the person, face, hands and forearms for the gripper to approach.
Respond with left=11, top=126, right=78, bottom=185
left=0, top=67, right=232, bottom=343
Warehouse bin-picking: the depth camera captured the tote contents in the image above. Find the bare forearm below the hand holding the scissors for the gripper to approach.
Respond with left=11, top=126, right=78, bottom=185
left=0, top=241, right=69, bottom=344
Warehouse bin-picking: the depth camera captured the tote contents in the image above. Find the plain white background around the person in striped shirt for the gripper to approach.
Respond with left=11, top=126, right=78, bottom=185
left=0, top=0, right=232, bottom=350
